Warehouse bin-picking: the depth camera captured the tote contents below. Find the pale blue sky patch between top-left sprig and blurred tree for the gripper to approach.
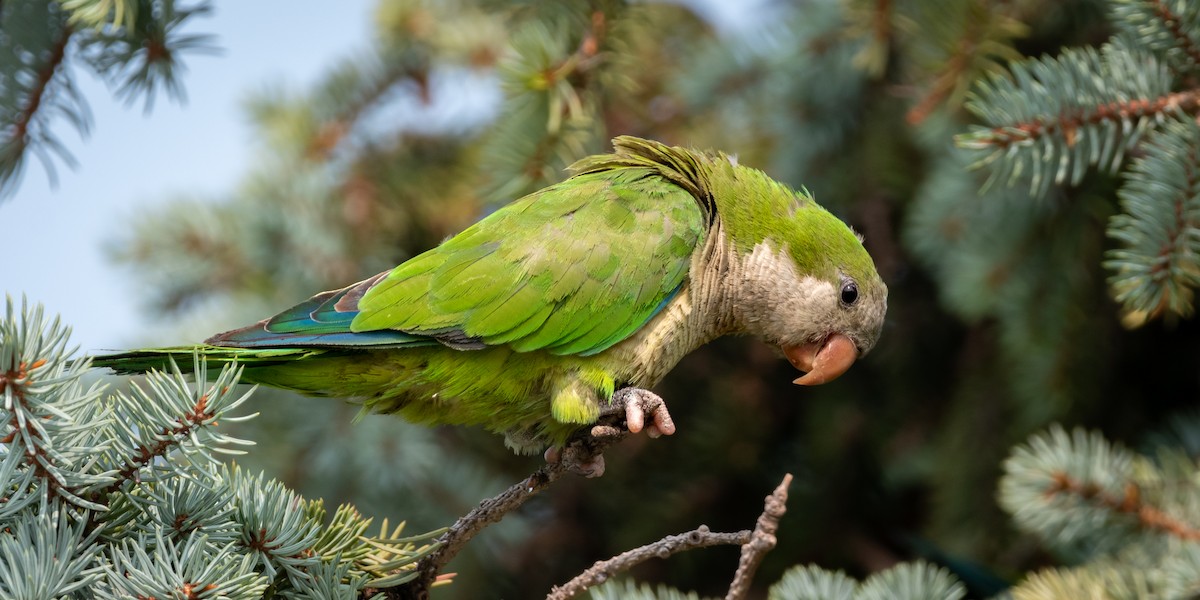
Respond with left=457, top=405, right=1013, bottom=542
left=0, top=0, right=376, bottom=352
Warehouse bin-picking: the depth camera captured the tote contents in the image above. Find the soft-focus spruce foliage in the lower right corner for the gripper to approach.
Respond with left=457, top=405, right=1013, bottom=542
left=1000, top=427, right=1200, bottom=600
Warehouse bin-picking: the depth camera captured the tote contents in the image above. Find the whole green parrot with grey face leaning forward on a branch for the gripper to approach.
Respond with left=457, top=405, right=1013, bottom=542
left=94, top=137, right=887, bottom=468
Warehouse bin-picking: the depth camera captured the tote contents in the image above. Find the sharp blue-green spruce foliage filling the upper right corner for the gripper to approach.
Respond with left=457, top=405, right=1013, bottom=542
left=958, top=0, right=1200, bottom=326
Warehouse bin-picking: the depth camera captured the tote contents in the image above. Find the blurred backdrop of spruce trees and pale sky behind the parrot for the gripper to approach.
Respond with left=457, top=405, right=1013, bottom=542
left=0, top=0, right=1200, bottom=598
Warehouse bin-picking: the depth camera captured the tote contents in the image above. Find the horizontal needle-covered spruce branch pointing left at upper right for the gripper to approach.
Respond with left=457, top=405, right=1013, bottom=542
left=955, top=37, right=1185, bottom=196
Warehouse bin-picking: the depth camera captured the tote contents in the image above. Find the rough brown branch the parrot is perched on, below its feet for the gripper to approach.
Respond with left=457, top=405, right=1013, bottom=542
left=385, top=422, right=628, bottom=600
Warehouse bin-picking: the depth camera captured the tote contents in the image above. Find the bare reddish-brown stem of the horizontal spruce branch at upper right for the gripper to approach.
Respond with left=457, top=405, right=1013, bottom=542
left=972, top=89, right=1200, bottom=149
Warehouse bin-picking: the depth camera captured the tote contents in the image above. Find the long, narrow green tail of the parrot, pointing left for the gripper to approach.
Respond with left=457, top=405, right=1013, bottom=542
left=91, top=346, right=329, bottom=374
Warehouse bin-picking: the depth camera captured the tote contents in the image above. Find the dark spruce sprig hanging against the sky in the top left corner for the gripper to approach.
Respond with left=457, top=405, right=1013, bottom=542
left=0, top=0, right=214, bottom=200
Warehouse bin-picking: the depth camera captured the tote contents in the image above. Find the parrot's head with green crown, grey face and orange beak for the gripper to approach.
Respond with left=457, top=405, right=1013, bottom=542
left=718, top=167, right=888, bottom=385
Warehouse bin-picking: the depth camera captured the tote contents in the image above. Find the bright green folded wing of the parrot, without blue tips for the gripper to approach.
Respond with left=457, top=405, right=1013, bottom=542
left=349, top=167, right=706, bottom=355
